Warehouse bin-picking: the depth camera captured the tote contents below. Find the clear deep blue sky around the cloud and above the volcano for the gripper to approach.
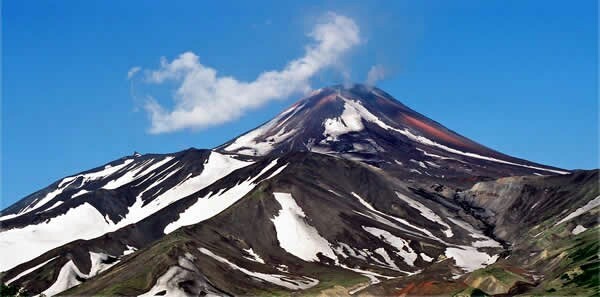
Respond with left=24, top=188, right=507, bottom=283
left=1, top=0, right=598, bottom=208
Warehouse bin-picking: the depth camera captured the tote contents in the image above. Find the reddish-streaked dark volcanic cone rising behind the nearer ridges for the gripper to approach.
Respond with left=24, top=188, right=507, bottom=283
left=217, top=84, right=567, bottom=177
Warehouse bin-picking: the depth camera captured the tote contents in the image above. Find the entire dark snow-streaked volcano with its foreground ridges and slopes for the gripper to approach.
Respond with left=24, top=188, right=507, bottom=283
left=0, top=85, right=600, bottom=296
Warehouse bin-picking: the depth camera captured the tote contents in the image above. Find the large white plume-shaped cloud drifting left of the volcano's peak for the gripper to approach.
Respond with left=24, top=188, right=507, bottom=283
left=135, top=13, right=360, bottom=133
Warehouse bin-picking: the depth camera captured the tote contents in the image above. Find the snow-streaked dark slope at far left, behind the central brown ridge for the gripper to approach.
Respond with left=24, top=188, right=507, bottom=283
left=0, top=152, right=252, bottom=271
